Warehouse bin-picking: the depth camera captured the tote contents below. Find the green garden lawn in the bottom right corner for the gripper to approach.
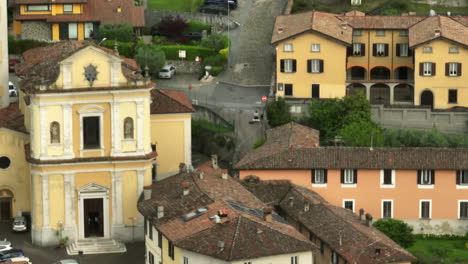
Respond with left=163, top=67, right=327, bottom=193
left=408, top=240, right=468, bottom=264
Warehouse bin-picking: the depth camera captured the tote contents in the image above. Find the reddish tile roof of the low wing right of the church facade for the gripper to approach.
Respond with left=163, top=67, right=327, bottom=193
left=151, top=89, right=195, bottom=115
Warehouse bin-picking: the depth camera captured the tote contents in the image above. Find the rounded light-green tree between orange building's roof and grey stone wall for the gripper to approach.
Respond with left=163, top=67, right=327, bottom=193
left=338, top=121, right=384, bottom=147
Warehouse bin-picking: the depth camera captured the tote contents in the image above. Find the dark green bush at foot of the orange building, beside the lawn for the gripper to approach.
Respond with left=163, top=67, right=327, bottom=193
left=373, top=219, right=415, bottom=248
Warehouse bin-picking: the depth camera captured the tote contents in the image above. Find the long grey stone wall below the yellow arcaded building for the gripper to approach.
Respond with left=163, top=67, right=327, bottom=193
left=372, top=105, right=468, bottom=134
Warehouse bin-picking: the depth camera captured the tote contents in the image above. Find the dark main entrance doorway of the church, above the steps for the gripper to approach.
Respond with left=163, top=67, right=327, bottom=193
left=83, top=198, right=105, bottom=238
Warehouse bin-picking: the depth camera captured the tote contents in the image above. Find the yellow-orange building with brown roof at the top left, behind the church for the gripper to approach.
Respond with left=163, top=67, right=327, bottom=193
left=13, top=0, right=145, bottom=40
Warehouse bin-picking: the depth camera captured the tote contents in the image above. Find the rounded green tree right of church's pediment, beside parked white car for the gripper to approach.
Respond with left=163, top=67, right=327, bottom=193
left=135, top=44, right=166, bottom=74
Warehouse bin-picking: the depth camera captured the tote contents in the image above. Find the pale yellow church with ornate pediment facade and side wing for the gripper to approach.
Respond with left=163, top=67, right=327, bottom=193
left=0, top=41, right=193, bottom=254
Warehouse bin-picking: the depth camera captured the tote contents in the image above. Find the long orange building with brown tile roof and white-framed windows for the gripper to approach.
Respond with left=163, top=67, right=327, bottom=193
left=235, top=123, right=468, bottom=234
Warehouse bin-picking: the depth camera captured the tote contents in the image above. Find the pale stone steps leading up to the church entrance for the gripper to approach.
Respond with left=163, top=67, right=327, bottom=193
left=67, top=238, right=127, bottom=255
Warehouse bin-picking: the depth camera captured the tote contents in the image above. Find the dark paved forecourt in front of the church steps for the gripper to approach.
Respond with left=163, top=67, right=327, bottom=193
left=0, top=222, right=145, bottom=264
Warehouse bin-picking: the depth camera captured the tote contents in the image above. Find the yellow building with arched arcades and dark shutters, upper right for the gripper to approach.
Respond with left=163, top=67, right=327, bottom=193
left=272, top=11, right=468, bottom=109
